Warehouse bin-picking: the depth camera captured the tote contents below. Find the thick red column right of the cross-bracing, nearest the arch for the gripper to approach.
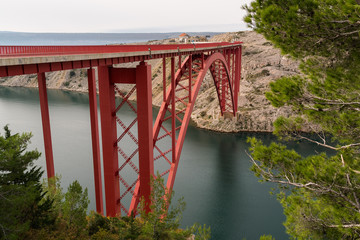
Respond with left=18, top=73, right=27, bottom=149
left=136, top=62, right=154, bottom=211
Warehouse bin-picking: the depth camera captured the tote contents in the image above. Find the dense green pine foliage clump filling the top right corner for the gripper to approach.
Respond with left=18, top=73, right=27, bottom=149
left=245, top=0, right=360, bottom=60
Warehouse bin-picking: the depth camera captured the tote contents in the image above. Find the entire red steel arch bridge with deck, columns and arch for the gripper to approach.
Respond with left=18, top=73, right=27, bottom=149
left=0, top=42, right=241, bottom=216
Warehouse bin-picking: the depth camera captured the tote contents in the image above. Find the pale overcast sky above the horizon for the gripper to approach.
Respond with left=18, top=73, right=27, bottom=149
left=0, top=0, right=252, bottom=33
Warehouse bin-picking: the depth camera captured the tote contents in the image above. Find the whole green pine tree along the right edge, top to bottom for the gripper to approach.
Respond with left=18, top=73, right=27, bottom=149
left=244, top=0, right=360, bottom=239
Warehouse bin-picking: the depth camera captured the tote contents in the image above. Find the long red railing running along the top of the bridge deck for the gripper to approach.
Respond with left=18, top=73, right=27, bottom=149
left=0, top=42, right=242, bottom=57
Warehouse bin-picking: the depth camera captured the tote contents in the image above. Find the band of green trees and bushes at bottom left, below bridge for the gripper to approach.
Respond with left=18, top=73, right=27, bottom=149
left=0, top=126, right=210, bottom=240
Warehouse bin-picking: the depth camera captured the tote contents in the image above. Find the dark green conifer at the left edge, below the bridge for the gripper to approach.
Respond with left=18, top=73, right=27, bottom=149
left=0, top=126, right=53, bottom=239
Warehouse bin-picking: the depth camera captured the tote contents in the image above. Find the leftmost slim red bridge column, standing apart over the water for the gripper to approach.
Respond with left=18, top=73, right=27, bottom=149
left=38, top=72, right=55, bottom=178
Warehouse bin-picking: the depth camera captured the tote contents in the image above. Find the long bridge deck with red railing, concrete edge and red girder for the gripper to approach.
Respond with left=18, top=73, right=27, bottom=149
left=0, top=42, right=241, bottom=77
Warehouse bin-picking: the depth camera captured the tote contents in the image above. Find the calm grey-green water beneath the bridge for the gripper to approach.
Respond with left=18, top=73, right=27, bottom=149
left=0, top=87, right=330, bottom=240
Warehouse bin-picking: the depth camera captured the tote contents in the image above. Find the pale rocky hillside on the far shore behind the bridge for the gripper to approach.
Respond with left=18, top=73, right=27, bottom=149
left=0, top=31, right=299, bottom=132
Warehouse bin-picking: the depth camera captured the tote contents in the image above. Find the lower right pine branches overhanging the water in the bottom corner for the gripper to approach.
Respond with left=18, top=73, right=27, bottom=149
left=250, top=138, right=360, bottom=239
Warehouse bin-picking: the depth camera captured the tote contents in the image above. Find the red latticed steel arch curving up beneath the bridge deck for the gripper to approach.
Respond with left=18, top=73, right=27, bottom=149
left=154, top=53, right=235, bottom=195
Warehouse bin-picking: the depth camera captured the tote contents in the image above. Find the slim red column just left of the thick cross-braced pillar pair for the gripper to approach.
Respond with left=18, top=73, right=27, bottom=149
left=87, top=69, right=104, bottom=214
